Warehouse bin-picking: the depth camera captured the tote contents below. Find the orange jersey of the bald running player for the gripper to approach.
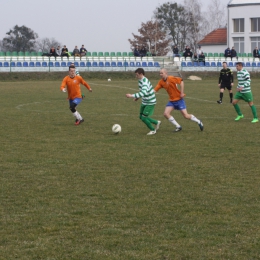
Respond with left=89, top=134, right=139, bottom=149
left=154, top=76, right=185, bottom=101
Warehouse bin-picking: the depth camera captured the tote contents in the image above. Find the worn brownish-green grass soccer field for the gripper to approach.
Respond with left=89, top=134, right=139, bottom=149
left=0, top=79, right=260, bottom=260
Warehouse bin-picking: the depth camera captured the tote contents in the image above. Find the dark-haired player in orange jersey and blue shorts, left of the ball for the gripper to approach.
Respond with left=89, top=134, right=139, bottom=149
left=60, top=65, right=92, bottom=125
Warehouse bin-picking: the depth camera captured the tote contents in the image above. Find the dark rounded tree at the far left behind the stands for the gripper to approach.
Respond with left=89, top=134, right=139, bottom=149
left=3, top=25, right=38, bottom=52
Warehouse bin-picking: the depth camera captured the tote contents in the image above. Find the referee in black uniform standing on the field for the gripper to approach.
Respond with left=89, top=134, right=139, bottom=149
left=217, top=61, right=233, bottom=104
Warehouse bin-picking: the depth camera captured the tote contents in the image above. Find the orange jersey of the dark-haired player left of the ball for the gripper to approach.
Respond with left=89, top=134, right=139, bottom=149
left=60, top=76, right=91, bottom=99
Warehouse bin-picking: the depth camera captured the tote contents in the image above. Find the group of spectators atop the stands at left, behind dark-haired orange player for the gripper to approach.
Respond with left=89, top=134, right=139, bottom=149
left=42, top=44, right=87, bottom=57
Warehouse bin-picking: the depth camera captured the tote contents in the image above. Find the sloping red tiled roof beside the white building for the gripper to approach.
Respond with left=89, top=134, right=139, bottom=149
left=198, top=28, right=227, bottom=45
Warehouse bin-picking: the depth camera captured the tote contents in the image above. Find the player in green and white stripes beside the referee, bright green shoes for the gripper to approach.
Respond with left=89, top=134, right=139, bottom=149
left=232, top=62, right=259, bottom=123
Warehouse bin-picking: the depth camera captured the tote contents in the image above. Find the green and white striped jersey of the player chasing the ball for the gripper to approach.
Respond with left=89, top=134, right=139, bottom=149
left=134, top=77, right=156, bottom=105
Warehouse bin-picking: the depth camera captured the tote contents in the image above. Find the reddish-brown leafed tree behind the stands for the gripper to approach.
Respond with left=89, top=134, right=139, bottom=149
left=128, top=20, right=171, bottom=56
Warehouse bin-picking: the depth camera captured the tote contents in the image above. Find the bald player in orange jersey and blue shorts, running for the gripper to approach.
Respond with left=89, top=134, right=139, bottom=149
left=154, top=69, right=203, bottom=132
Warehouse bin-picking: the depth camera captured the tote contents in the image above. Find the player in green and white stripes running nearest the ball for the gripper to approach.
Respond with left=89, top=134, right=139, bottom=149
left=126, top=68, right=161, bottom=135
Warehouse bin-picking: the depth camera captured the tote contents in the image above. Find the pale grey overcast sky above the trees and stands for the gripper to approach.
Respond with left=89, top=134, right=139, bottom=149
left=0, top=0, right=229, bottom=52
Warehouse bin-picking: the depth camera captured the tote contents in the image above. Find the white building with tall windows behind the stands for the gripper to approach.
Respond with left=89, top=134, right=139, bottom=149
left=227, top=0, right=260, bottom=53
